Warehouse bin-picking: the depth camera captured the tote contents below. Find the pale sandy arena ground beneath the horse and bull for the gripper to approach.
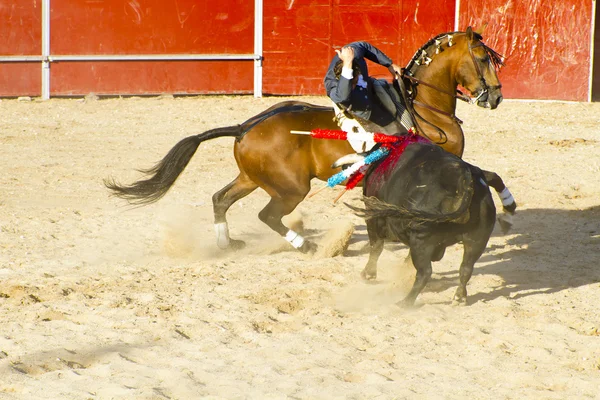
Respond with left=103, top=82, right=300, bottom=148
left=0, top=96, right=600, bottom=399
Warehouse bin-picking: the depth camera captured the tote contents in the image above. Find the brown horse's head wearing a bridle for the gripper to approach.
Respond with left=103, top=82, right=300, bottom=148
left=456, top=27, right=503, bottom=110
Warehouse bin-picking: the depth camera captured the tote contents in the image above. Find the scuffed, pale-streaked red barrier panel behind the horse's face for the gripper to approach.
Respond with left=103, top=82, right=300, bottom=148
left=460, top=0, right=593, bottom=101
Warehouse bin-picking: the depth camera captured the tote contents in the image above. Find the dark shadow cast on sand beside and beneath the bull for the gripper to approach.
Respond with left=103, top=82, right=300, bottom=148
left=344, top=206, right=600, bottom=304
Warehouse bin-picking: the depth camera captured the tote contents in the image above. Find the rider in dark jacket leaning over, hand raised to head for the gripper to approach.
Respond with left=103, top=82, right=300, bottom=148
left=324, top=42, right=413, bottom=153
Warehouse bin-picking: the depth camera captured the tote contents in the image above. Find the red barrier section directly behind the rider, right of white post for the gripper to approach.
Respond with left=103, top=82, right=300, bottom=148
left=263, top=0, right=455, bottom=95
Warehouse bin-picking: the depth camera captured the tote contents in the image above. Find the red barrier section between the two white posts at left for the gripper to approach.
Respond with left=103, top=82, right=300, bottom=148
left=51, top=0, right=254, bottom=96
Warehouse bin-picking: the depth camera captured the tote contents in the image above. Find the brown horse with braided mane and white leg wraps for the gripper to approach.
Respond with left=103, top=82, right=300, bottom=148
left=105, top=28, right=505, bottom=252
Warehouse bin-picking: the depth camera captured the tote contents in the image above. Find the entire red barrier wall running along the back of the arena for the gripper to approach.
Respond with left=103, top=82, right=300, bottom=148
left=0, top=0, right=595, bottom=101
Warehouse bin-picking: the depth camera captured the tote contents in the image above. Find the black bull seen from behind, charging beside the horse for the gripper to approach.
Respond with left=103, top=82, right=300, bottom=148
left=348, top=143, right=496, bottom=306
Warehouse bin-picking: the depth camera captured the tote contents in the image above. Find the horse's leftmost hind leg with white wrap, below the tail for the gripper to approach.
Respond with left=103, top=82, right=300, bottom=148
left=213, top=174, right=258, bottom=250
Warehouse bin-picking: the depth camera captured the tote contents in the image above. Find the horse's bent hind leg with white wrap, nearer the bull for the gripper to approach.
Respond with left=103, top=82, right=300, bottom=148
left=258, top=193, right=317, bottom=253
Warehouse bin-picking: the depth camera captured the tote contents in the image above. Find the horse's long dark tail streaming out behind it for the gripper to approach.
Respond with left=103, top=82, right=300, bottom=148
left=104, top=125, right=242, bottom=205
